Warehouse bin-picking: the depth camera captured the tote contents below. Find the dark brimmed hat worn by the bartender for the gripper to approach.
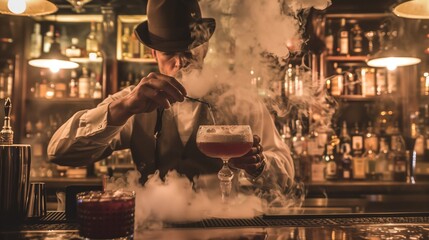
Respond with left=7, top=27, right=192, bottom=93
left=134, top=0, right=216, bottom=52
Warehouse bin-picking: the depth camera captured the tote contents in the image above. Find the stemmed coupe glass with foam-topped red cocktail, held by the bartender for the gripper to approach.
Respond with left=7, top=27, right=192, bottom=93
left=197, top=125, right=253, bottom=203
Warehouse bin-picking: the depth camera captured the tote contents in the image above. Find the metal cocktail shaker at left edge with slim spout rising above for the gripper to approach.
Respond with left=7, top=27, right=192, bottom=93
left=0, top=98, right=31, bottom=227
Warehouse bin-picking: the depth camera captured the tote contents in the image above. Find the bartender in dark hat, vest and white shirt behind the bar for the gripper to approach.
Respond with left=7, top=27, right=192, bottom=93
left=48, top=0, right=294, bottom=188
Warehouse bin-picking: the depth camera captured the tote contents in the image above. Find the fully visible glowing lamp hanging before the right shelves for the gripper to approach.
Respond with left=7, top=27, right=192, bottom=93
left=367, top=48, right=421, bottom=70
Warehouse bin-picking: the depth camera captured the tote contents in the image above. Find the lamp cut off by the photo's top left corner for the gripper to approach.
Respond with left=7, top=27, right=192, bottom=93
left=0, top=0, right=58, bottom=16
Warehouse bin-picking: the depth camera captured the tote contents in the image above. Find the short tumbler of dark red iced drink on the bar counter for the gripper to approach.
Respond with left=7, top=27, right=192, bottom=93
left=77, top=191, right=135, bottom=239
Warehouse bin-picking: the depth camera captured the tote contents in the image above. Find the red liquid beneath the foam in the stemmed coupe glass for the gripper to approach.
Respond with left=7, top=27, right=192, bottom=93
left=197, top=142, right=253, bottom=158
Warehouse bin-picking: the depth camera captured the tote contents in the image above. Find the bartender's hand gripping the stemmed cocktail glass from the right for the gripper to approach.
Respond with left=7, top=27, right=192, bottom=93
left=229, top=135, right=265, bottom=176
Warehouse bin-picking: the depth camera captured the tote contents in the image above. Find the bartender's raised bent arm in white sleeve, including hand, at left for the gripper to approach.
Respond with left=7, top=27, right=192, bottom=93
left=48, top=73, right=186, bottom=166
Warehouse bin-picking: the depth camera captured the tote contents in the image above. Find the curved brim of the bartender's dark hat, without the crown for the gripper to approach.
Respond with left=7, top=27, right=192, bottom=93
left=134, top=18, right=216, bottom=52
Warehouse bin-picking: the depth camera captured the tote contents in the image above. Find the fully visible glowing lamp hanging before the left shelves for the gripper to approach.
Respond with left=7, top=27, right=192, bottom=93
left=28, top=42, right=79, bottom=72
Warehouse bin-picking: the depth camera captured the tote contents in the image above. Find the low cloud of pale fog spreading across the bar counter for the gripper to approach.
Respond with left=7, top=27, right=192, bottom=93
left=107, top=171, right=266, bottom=229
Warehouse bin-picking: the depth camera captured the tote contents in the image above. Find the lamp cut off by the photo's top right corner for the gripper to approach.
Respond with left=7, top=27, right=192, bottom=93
left=393, top=0, right=429, bottom=19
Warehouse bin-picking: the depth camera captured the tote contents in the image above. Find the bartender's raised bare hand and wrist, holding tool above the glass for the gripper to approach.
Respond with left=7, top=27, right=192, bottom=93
left=108, top=72, right=187, bottom=125
